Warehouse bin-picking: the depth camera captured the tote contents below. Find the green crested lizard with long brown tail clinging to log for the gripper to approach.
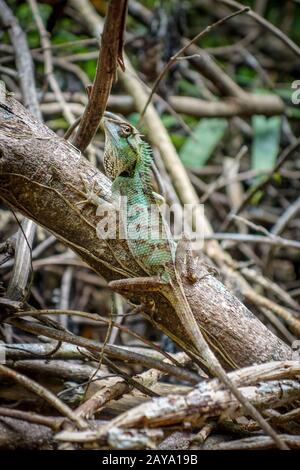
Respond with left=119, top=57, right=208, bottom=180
left=103, top=113, right=288, bottom=450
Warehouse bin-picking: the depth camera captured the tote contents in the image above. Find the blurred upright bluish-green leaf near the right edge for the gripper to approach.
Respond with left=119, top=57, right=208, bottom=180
left=251, top=115, right=281, bottom=183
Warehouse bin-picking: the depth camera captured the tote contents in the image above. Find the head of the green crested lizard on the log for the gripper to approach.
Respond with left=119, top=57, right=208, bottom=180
left=102, top=112, right=143, bottom=180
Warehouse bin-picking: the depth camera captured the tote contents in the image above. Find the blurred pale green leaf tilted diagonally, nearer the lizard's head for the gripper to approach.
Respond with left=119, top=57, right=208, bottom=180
left=180, top=118, right=228, bottom=168
